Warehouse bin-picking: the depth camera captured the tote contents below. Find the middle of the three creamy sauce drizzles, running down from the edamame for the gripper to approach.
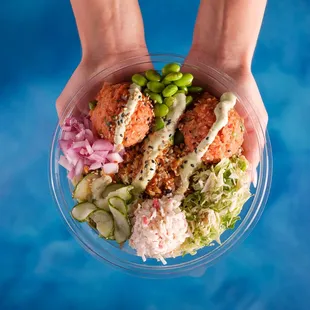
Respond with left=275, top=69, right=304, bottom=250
left=132, top=94, right=186, bottom=192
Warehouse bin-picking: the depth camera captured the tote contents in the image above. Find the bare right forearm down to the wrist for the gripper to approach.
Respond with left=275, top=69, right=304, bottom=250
left=191, top=0, right=267, bottom=69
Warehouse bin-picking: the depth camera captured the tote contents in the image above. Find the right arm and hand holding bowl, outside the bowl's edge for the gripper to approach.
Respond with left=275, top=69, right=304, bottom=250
left=186, top=0, right=268, bottom=185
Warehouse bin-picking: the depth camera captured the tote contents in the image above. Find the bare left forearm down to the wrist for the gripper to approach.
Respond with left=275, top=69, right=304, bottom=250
left=71, top=0, right=146, bottom=58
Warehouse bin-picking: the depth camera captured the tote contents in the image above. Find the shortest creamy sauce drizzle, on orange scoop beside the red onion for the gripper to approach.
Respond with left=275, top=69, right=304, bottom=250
left=114, top=83, right=142, bottom=148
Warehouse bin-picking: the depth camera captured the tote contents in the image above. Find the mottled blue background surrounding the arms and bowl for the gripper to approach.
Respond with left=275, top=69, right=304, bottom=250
left=0, top=0, right=310, bottom=310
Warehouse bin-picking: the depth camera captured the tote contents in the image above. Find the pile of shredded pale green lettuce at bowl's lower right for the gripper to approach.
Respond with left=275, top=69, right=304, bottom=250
left=180, top=156, right=251, bottom=254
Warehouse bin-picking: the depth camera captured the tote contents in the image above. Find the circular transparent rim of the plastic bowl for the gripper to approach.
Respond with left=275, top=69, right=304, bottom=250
left=49, top=53, right=272, bottom=278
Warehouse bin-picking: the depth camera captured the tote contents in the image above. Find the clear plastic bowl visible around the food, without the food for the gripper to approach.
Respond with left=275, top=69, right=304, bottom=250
left=50, top=54, right=272, bottom=278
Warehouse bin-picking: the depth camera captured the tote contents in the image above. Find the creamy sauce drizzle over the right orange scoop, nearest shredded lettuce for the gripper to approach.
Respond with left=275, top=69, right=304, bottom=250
left=176, top=92, right=237, bottom=195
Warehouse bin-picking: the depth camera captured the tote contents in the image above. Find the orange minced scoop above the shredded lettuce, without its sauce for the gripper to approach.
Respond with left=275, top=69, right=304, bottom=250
left=178, top=92, right=244, bottom=163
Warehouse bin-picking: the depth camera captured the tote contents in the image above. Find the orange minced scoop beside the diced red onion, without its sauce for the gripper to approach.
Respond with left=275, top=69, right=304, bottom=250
left=90, top=83, right=154, bottom=147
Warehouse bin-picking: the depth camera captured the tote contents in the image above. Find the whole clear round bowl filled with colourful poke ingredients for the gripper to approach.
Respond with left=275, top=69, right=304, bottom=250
left=50, top=55, right=272, bottom=277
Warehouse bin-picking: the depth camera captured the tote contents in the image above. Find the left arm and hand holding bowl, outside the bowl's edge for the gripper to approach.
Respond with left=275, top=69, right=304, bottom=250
left=56, top=0, right=147, bottom=117
